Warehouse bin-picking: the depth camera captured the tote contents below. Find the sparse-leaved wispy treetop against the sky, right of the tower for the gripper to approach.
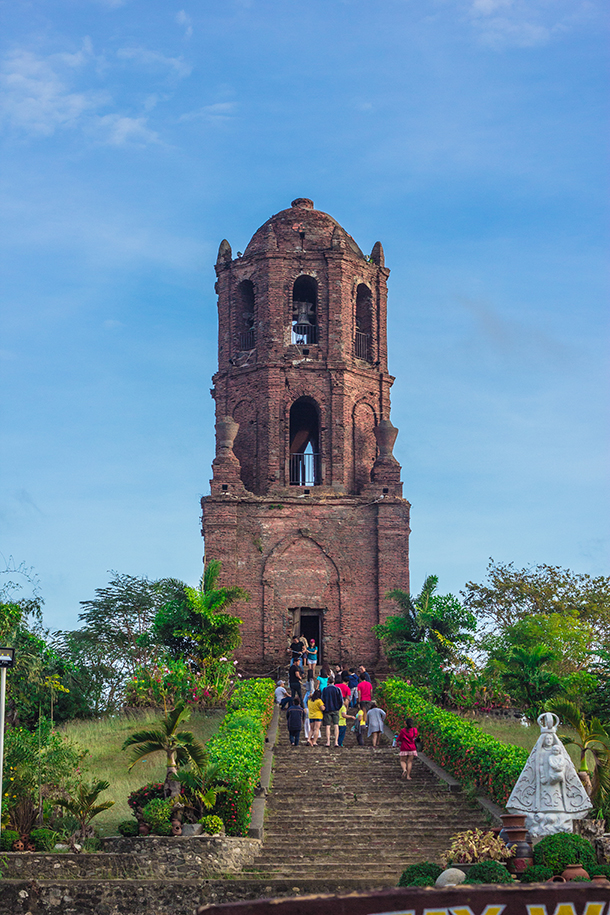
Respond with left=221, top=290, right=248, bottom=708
left=462, top=559, right=610, bottom=640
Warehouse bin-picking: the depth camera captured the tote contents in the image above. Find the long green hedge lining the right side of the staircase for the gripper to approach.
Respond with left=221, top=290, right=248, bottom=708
left=377, top=677, right=528, bottom=806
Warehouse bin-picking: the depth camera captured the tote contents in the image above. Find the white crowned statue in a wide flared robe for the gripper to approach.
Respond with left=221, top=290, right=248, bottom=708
left=506, top=712, right=592, bottom=839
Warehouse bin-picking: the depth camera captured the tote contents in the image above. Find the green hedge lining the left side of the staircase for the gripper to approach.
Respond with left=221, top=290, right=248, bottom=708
left=207, top=679, right=275, bottom=836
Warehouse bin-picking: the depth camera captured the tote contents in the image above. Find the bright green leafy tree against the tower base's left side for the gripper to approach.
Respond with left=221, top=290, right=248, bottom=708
left=152, top=560, right=250, bottom=670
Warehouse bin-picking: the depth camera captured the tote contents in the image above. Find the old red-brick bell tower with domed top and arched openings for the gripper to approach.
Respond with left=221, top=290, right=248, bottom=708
left=201, top=198, right=410, bottom=672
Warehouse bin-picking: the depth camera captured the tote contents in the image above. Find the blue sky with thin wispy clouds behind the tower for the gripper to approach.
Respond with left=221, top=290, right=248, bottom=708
left=0, top=0, right=609, bottom=628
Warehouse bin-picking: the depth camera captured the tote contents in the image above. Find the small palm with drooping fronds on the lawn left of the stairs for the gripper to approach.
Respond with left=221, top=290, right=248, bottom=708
left=123, top=702, right=207, bottom=797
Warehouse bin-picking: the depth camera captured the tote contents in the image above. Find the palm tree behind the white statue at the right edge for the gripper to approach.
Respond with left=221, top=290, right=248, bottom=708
left=545, top=698, right=610, bottom=807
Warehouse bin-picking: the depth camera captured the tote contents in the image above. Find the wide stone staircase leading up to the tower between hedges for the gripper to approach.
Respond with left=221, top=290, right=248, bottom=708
left=241, top=715, right=488, bottom=892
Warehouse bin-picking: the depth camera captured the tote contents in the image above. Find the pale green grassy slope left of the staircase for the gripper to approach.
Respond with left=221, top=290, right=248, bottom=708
left=62, top=710, right=224, bottom=836
